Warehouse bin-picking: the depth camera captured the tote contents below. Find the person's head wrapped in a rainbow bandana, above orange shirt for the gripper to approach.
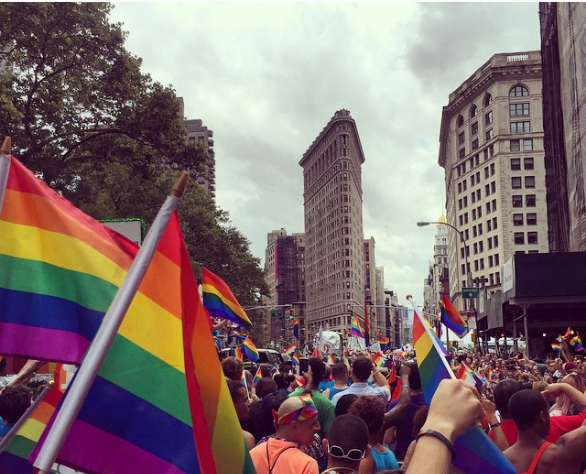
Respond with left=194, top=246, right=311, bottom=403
left=276, top=394, right=320, bottom=446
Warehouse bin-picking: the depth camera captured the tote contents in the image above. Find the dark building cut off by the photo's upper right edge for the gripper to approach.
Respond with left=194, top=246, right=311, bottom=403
left=539, top=2, right=586, bottom=252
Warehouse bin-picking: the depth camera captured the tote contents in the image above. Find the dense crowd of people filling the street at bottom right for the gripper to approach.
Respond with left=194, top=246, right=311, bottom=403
left=222, top=344, right=586, bottom=474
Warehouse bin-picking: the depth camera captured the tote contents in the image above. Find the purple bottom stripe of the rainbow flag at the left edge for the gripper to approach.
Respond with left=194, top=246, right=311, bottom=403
left=0, top=322, right=89, bottom=363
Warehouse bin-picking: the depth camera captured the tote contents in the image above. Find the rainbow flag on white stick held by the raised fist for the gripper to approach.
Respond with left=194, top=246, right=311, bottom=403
left=411, top=300, right=516, bottom=474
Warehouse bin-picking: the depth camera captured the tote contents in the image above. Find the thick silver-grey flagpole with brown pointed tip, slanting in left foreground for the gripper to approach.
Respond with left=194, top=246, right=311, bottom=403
left=33, top=172, right=188, bottom=473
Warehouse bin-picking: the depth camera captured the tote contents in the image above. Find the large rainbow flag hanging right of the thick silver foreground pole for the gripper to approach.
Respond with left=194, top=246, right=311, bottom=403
left=33, top=214, right=254, bottom=474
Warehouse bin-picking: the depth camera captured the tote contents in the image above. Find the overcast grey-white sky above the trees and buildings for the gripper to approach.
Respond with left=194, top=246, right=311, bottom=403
left=111, top=2, right=540, bottom=304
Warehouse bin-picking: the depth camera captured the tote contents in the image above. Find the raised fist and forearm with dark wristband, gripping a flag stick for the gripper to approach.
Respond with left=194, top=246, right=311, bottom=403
left=405, top=379, right=484, bottom=474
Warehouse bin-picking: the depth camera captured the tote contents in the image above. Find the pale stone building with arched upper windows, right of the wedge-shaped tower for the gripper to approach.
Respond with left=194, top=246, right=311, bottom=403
left=438, top=51, right=549, bottom=310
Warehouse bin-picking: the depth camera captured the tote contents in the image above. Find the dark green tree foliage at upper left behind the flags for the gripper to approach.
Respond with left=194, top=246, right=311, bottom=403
left=0, top=2, right=267, bottom=312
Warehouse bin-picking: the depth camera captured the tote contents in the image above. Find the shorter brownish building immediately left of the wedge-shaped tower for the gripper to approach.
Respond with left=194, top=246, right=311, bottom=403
left=264, top=229, right=305, bottom=349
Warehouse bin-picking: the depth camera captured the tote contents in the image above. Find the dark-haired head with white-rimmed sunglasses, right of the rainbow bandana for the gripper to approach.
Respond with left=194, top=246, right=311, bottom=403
left=323, top=415, right=370, bottom=470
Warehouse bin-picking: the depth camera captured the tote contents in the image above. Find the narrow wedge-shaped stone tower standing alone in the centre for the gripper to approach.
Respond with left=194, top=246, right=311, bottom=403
left=299, top=110, right=365, bottom=342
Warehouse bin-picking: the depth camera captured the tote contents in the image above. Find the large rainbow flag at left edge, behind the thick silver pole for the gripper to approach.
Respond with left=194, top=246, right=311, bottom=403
left=0, top=155, right=138, bottom=364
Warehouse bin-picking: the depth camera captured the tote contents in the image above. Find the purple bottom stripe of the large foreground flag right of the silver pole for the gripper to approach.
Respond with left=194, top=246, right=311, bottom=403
left=52, top=413, right=185, bottom=474
